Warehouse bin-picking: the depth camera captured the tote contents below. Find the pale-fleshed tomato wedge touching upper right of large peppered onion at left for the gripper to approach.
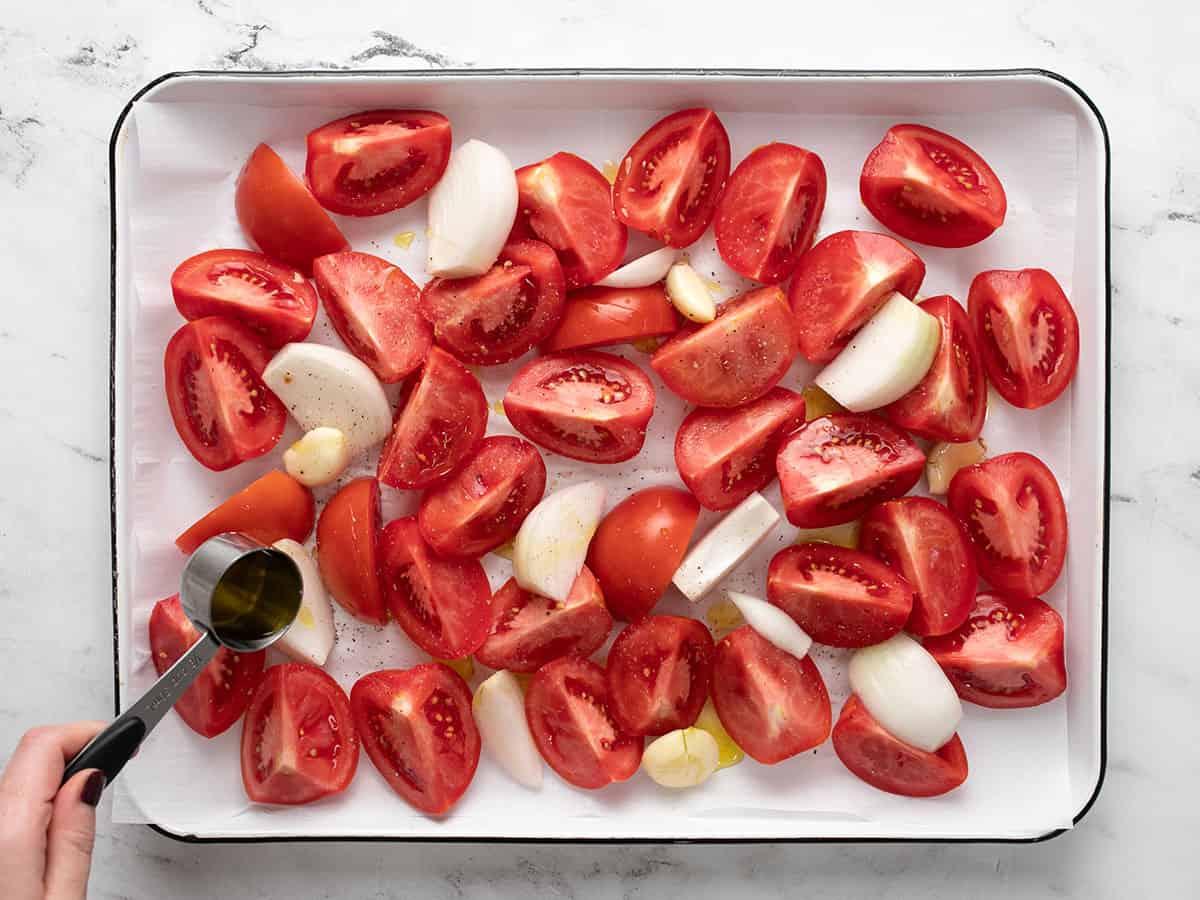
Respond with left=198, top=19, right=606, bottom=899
left=312, top=250, right=433, bottom=384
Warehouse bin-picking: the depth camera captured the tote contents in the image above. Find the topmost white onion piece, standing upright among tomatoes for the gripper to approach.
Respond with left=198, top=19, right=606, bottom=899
left=428, top=139, right=517, bottom=278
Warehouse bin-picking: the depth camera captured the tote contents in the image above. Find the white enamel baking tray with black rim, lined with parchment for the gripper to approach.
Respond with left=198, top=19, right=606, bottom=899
left=110, top=70, right=1109, bottom=841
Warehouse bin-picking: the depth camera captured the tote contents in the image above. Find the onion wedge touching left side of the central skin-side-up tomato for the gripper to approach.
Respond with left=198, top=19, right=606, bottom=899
left=512, top=481, right=605, bottom=604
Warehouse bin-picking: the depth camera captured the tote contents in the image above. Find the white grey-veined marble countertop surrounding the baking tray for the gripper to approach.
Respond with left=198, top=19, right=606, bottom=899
left=0, top=0, right=1200, bottom=900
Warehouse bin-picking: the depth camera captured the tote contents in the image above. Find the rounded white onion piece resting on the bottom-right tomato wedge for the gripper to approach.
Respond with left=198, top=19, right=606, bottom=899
left=850, top=631, right=962, bottom=752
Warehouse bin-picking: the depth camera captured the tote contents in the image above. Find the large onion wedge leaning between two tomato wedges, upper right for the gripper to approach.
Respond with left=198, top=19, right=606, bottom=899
left=815, top=294, right=942, bottom=413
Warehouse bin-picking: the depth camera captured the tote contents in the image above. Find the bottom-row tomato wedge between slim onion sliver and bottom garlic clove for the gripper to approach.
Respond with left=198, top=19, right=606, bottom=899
left=526, top=656, right=642, bottom=790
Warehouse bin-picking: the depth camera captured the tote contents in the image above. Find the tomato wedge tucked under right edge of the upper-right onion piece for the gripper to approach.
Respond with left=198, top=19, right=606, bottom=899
left=878, top=295, right=988, bottom=444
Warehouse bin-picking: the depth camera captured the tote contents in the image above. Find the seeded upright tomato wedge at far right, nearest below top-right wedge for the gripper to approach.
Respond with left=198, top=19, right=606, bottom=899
left=967, top=269, right=1079, bottom=409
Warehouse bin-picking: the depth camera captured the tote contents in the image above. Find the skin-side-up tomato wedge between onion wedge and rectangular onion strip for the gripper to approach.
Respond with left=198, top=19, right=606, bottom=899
left=588, top=487, right=700, bottom=622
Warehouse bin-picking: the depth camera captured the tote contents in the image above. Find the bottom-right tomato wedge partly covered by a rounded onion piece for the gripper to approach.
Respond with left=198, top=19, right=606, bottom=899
left=833, top=694, right=967, bottom=797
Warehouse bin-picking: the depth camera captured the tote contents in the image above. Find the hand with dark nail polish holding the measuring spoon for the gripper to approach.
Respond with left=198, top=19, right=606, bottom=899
left=0, top=722, right=104, bottom=900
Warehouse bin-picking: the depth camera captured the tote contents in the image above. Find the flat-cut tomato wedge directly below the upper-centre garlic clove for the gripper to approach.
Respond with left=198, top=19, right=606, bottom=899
left=650, top=288, right=796, bottom=407
